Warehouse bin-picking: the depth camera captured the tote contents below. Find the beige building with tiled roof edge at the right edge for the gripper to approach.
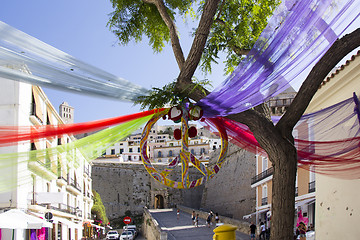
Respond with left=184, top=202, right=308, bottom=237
left=307, top=51, right=360, bottom=240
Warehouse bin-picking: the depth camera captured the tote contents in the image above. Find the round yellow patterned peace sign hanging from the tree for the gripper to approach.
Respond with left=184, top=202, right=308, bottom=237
left=140, top=105, right=228, bottom=189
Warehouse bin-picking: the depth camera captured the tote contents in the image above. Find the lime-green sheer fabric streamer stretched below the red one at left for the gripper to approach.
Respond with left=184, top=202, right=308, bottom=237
left=0, top=115, right=152, bottom=193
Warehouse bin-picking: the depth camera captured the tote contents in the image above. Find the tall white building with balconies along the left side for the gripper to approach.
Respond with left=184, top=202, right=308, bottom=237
left=0, top=79, right=93, bottom=240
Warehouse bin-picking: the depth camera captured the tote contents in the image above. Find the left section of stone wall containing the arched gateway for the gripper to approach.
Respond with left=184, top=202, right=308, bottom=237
left=92, top=161, right=204, bottom=220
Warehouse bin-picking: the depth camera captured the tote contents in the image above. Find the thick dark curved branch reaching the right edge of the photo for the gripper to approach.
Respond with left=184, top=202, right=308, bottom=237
left=276, top=28, right=360, bottom=135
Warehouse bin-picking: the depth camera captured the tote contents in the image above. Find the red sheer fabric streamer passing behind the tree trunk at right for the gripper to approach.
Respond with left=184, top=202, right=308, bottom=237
left=204, top=118, right=360, bottom=179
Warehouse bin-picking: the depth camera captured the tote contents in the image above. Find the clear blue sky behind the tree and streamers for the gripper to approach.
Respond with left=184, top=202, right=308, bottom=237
left=0, top=0, right=225, bottom=122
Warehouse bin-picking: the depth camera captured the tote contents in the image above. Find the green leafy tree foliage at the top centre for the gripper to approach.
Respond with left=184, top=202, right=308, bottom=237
left=108, top=0, right=279, bottom=73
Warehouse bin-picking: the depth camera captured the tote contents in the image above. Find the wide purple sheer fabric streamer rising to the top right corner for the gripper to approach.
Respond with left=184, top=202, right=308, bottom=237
left=198, top=0, right=360, bottom=117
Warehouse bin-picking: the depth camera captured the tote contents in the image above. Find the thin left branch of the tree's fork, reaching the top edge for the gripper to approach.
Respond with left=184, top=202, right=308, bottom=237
left=143, top=0, right=185, bottom=71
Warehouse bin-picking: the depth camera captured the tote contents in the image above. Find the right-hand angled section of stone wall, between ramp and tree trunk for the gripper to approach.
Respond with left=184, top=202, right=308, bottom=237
left=201, top=144, right=256, bottom=219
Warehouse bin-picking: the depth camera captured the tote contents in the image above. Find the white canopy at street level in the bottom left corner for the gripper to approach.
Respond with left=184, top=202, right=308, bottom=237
left=0, top=209, right=52, bottom=229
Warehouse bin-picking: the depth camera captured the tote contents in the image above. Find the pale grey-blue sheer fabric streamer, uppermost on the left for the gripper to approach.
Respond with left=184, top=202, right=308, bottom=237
left=0, top=21, right=148, bottom=102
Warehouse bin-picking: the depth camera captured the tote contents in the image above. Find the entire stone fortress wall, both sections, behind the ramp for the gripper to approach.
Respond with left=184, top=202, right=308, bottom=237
left=92, top=142, right=256, bottom=223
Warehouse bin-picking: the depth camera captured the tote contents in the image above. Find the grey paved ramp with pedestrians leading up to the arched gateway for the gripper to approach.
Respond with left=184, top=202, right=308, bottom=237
left=149, top=209, right=250, bottom=240
